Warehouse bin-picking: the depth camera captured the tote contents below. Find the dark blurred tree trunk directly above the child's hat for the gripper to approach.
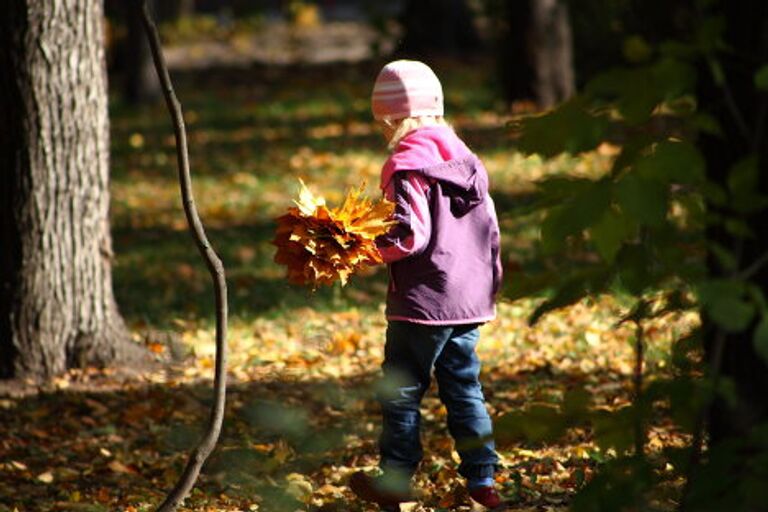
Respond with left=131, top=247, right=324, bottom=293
left=397, top=0, right=480, bottom=57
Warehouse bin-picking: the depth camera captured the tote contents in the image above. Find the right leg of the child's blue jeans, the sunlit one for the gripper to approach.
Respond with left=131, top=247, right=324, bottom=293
left=435, top=325, right=499, bottom=481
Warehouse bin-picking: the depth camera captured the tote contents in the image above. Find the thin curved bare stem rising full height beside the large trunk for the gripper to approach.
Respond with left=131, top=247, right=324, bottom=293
left=139, top=0, right=227, bottom=512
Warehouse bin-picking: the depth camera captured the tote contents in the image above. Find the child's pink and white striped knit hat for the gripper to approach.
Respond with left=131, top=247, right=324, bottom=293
left=371, top=60, right=443, bottom=120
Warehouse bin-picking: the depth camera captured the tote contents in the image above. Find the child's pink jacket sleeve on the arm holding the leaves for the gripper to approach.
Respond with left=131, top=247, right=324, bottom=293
left=376, top=171, right=432, bottom=263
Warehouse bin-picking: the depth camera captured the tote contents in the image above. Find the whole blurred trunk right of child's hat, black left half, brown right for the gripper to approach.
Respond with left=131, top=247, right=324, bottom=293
left=496, top=0, right=575, bottom=108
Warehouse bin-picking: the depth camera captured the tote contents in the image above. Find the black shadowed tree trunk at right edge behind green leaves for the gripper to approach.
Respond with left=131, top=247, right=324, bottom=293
left=699, top=0, right=768, bottom=445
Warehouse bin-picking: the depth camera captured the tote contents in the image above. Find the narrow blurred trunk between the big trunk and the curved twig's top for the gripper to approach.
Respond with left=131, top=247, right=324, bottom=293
left=122, top=0, right=160, bottom=105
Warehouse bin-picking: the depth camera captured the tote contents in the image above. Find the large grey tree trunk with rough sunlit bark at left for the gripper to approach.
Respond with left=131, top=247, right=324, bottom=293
left=0, top=0, right=139, bottom=378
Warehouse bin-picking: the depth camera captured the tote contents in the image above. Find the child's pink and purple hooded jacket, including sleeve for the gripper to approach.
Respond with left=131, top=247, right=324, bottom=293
left=377, top=126, right=502, bottom=325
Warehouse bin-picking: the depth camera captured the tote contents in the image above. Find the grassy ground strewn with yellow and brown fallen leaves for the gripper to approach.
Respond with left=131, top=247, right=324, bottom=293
left=0, top=58, right=697, bottom=512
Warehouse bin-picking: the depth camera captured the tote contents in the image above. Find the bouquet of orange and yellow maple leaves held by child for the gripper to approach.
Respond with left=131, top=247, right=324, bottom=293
left=272, top=180, right=394, bottom=288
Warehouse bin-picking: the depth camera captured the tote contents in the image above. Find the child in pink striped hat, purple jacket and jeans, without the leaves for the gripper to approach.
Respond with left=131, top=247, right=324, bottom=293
left=350, top=60, right=508, bottom=509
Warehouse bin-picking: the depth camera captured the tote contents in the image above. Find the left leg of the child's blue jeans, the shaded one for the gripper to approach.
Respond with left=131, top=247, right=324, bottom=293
left=379, top=322, right=448, bottom=477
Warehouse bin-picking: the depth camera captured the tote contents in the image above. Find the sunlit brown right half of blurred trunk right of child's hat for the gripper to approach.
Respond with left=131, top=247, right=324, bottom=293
left=530, top=0, right=575, bottom=108
